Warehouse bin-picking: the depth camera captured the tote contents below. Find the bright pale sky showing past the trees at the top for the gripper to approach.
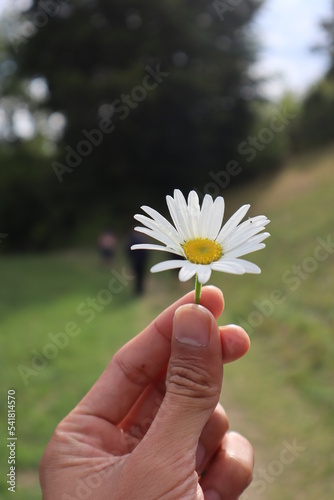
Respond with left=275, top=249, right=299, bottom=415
left=0, top=0, right=331, bottom=99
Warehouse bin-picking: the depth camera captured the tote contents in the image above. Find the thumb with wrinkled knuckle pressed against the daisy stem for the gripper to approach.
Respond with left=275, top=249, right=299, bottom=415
left=147, top=304, right=223, bottom=460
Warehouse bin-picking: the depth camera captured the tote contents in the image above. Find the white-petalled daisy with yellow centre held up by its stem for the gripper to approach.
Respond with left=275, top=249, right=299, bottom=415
left=131, top=189, right=270, bottom=302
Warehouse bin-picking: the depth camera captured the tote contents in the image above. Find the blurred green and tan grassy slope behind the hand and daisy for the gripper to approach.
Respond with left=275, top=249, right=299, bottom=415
left=0, top=146, right=334, bottom=500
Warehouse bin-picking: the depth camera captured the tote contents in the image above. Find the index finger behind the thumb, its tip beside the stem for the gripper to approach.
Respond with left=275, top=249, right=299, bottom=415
left=75, top=286, right=224, bottom=425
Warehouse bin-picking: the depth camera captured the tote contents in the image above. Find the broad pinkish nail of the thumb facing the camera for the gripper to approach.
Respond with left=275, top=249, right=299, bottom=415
left=174, top=304, right=211, bottom=347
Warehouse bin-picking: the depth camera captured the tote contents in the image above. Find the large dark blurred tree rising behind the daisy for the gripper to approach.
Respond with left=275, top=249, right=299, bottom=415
left=2, top=0, right=261, bottom=250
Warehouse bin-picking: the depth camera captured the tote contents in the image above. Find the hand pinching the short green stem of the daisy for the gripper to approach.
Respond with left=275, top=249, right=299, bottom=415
left=40, top=287, right=253, bottom=500
